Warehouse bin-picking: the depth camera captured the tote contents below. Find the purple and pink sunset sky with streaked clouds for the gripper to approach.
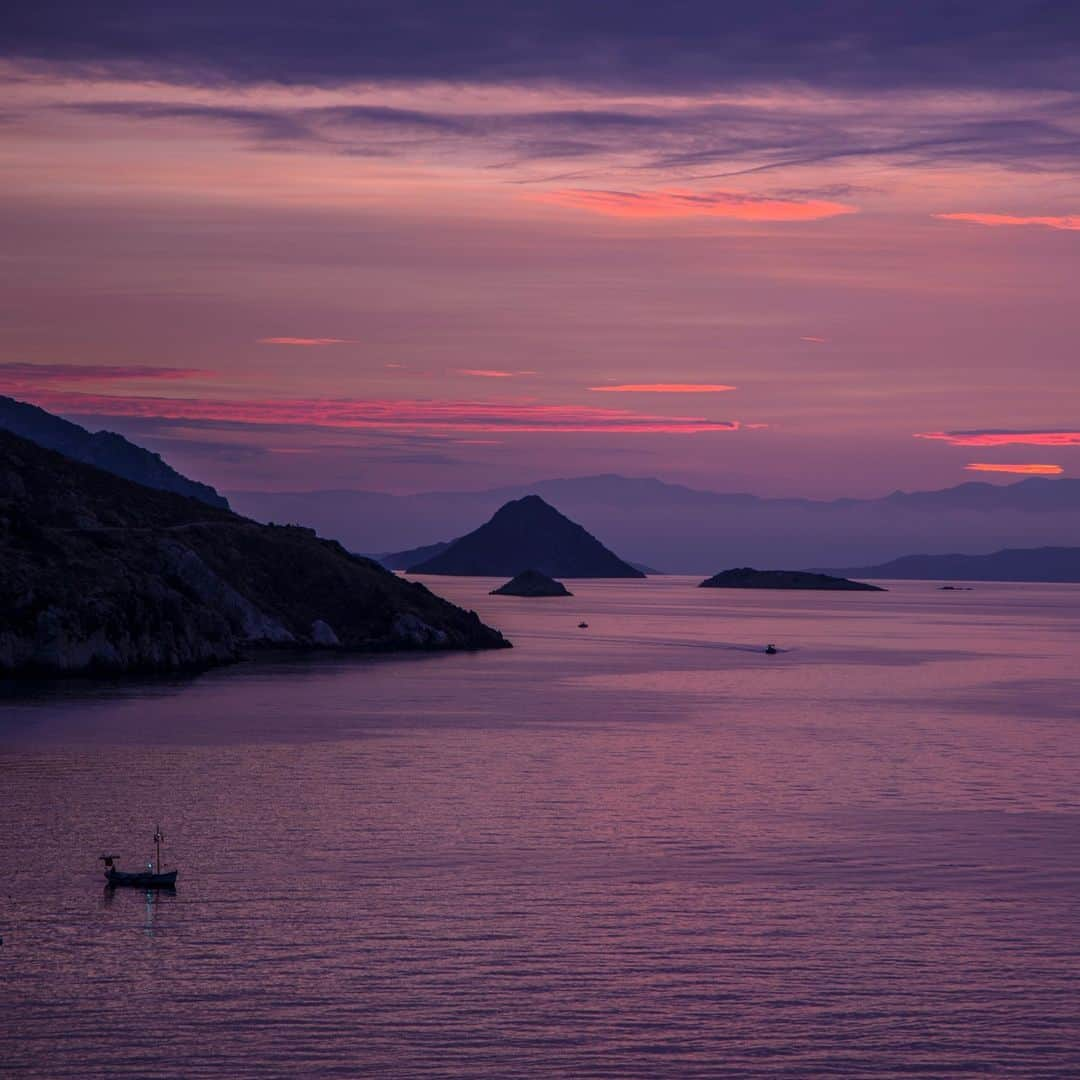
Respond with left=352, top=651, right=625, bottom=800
left=0, top=0, right=1080, bottom=497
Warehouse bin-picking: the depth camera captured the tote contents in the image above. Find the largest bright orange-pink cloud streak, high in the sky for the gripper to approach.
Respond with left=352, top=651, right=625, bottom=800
left=538, top=188, right=858, bottom=221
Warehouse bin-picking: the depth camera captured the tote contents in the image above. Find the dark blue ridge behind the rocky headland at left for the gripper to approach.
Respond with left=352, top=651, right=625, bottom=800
left=0, top=396, right=229, bottom=510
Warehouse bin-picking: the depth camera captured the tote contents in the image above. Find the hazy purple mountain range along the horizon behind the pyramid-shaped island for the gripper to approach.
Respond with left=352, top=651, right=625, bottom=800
left=229, top=475, right=1080, bottom=573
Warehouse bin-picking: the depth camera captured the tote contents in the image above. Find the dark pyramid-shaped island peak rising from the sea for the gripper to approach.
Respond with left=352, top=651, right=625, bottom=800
left=407, top=495, right=645, bottom=578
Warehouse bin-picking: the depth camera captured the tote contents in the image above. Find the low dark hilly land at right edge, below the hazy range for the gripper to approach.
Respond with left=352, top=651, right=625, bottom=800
left=829, top=548, right=1080, bottom=582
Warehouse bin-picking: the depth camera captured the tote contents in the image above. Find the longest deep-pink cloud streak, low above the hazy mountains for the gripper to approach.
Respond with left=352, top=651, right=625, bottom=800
left=27, top=391, right=741, bottom=434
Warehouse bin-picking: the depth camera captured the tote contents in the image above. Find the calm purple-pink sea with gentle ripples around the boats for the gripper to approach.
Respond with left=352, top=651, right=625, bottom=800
left=0, top=578, right=1080, bottom=1078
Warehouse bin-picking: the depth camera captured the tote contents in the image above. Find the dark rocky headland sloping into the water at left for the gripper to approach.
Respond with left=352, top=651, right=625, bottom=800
left=0, top=432, right=509, bottom=674
